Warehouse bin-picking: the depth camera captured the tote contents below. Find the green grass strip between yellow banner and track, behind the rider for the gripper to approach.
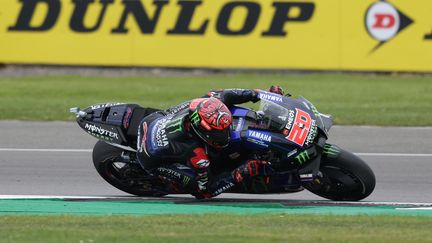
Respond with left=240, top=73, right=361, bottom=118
left=0, top=74, right=432, bottom=126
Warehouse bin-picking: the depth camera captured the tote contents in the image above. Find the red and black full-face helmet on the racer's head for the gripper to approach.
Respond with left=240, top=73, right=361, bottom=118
left=189, top=98, right=232, bottom=148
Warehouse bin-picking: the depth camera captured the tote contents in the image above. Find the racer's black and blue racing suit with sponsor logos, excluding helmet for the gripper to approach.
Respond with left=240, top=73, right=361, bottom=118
left=137, top=89, right=259, bottom=198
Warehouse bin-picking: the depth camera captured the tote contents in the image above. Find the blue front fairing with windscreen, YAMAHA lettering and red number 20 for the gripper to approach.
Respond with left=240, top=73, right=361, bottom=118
left=230, top=91, right=331, bottom=152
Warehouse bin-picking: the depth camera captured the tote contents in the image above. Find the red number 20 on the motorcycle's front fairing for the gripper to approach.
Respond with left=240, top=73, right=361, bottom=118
left=286, top=108, right=312, bottom=146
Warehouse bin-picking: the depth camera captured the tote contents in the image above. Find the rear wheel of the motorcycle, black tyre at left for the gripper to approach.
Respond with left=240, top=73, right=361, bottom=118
left=93, top=141, right=166, bottom=197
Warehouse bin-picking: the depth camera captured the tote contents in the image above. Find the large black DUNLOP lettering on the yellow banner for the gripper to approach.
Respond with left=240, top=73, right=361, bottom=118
left=8, top=0, right=315, bottom=38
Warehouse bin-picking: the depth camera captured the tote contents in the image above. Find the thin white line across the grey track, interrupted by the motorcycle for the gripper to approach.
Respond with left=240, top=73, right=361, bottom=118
left=0, top=148, right=432, bottom=157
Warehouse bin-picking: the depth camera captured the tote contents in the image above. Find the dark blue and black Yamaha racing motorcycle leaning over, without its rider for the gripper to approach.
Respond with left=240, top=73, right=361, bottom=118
left=70, top=90, right=375, bottom=201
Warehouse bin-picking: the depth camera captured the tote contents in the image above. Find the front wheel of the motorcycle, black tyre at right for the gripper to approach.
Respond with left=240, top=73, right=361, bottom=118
left=305, top=145, right=375, bottom=201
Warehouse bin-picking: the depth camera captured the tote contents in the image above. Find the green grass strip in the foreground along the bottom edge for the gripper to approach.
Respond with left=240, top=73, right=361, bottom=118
left=0, top=214, right=432, bottom=243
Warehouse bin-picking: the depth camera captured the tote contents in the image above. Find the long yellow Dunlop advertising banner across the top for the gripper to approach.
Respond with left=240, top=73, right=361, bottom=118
left=0, top=0, right=432, bottom=72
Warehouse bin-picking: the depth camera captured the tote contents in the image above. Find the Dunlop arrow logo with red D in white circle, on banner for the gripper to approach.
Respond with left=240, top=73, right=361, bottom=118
left=365, top=1, right=414, bottom=52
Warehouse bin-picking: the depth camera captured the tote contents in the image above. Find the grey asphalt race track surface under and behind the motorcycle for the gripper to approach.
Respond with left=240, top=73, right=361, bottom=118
left=0, top=121, right=432, bottom=203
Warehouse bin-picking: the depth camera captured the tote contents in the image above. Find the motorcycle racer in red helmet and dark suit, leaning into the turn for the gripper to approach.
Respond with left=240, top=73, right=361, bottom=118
left=137, top=86, right=283, bottom=199
